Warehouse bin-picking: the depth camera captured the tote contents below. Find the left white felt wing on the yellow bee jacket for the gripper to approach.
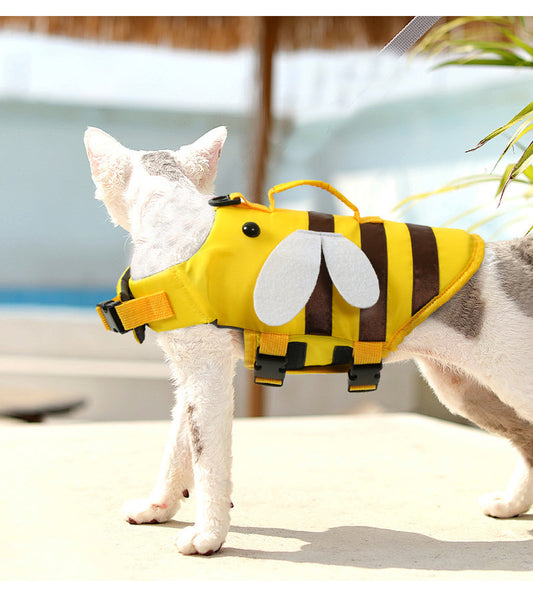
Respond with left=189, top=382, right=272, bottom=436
left=254, top=230, right=321, bottom=326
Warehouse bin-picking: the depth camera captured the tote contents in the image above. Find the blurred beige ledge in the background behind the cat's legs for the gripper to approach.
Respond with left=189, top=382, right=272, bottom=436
left=0, top=307, right=426, bottom=421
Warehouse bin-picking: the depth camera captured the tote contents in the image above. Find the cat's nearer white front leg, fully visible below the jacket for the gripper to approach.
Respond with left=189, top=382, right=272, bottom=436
left=161, top=325, right=239, bottom=555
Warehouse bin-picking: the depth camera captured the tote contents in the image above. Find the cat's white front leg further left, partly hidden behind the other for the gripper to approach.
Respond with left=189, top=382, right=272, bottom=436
left=121, top=400, right=193, bottom=524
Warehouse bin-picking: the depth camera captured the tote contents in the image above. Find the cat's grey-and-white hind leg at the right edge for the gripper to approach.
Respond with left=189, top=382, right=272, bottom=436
left=417, top=358, right=533, bottom=519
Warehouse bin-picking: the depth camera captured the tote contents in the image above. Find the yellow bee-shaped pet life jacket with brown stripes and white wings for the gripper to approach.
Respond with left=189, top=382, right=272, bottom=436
left=97, top=180, right=484, bottom=391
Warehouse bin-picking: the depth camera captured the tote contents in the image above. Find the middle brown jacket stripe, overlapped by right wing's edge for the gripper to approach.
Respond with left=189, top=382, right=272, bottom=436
left=354, top=222, right=389, bottom=341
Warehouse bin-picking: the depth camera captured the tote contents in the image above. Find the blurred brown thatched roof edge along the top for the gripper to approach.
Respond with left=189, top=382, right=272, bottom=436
left=0, top=16, right=420, bottom=51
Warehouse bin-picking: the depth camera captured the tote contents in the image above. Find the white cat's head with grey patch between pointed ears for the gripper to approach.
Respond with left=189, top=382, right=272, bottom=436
left=84, top=127, right=227, bottom=275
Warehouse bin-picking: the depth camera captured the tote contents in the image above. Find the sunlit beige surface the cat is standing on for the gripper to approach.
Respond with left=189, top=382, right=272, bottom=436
left=0, top=414, right=533, bottom=580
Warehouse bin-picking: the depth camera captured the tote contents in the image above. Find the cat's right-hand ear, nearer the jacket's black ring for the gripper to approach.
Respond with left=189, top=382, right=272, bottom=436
left=177, top=127, right=228, bottom=194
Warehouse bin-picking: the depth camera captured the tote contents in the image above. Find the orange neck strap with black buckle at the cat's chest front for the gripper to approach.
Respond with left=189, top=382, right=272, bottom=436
left=96, top=269, right=174, bottom=343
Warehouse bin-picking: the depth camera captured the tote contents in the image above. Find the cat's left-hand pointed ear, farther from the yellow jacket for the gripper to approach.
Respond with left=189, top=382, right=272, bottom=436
left=84, top=127, right=133, bottom=231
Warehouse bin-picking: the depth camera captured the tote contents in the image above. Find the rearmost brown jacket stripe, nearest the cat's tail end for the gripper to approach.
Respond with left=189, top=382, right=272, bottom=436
left=407, top=223, right=440, bottom=315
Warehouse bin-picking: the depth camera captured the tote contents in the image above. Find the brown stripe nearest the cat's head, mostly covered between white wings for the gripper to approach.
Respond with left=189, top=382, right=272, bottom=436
left=305, top=212, right=335, bottom=336
